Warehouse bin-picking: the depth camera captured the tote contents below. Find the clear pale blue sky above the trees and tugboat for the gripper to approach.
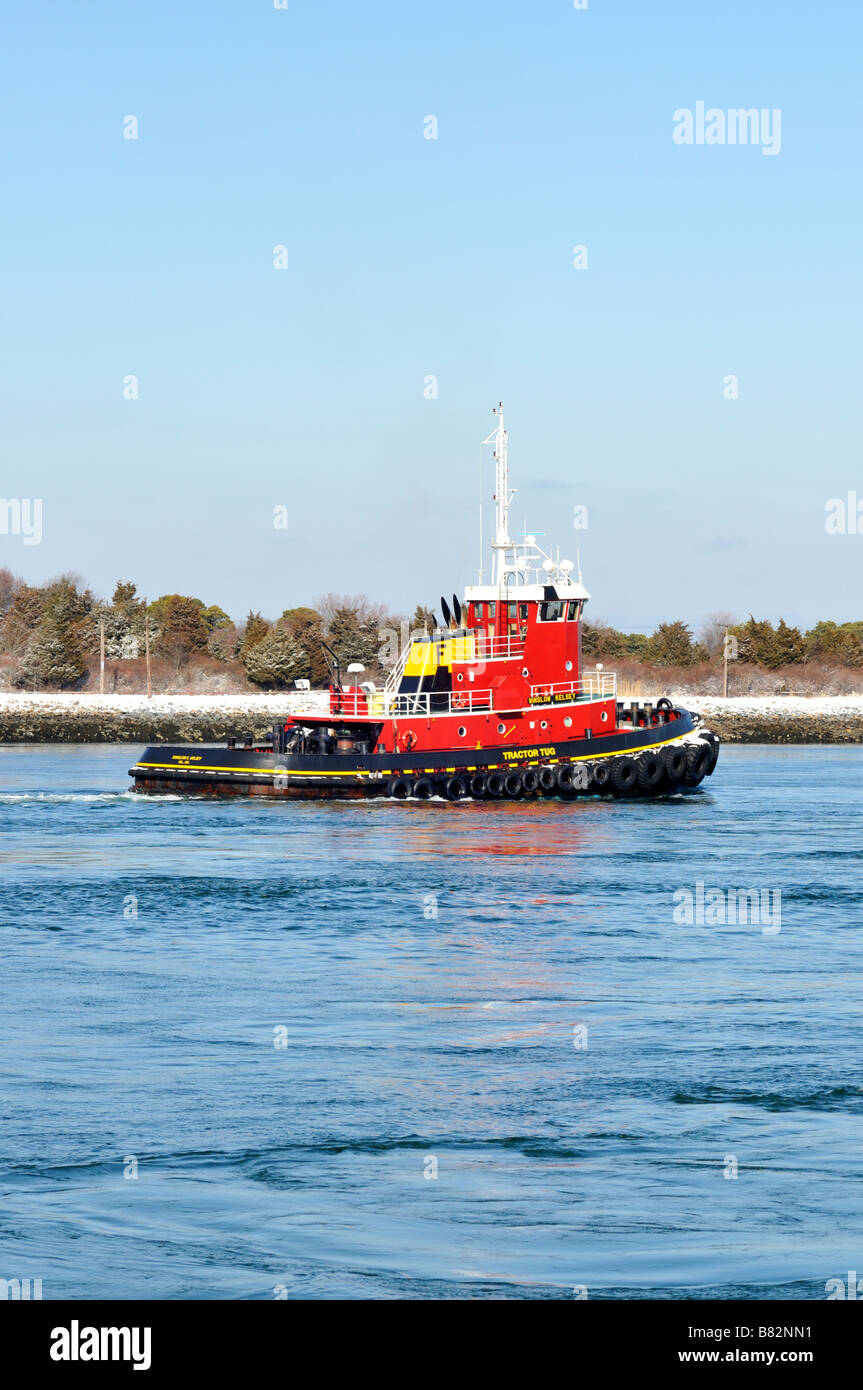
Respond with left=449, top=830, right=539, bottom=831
left=0, top=0, right=863, bottom=630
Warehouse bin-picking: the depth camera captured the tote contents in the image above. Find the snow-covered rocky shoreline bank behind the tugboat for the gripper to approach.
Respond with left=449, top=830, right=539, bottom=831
left=0, top=691, right=863, bottom=744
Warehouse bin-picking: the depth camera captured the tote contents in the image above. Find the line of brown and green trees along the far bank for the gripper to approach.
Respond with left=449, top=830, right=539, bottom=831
left=0, top=569, right=863, bottom=689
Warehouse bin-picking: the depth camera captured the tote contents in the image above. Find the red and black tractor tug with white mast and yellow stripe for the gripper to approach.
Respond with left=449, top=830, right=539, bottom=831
left=129, top=406, right=720, bottom=801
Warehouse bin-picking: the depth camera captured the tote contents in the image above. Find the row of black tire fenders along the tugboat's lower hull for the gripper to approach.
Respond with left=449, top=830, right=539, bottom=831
left=386, top=731, right=718, bottom=801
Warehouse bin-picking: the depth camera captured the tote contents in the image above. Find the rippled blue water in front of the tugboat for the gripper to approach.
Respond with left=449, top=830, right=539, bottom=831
left=0, top=746, right=863, bottom=1298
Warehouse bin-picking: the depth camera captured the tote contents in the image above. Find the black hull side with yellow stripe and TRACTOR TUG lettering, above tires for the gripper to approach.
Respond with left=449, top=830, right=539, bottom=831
left=129, top=710, right=700, bottom=801
